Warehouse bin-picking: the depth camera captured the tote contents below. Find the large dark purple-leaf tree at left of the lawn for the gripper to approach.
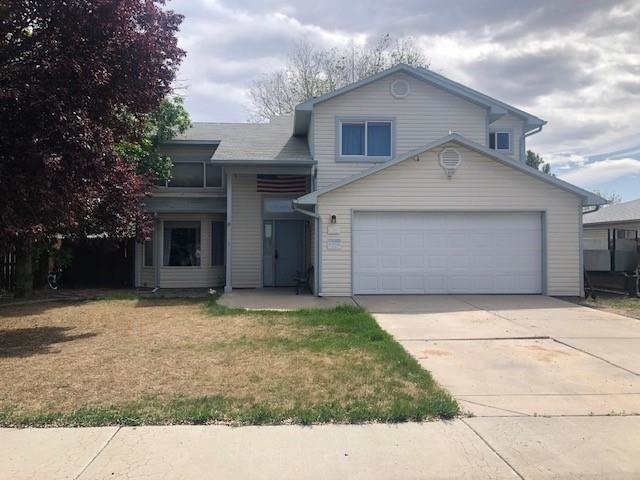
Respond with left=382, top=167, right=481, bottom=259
left=0, top=0, right=184, bottom=294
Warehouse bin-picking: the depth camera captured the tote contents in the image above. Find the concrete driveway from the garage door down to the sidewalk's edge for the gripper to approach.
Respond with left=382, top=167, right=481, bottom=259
left=356, top=295, right=640, bottom=416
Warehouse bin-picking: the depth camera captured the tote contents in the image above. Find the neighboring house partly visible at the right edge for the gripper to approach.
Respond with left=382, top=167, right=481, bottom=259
left=583, top=199, right=640, bottom=272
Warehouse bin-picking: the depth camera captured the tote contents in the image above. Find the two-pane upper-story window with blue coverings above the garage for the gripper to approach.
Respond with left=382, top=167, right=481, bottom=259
left=338, top=120, right=393, bottom=160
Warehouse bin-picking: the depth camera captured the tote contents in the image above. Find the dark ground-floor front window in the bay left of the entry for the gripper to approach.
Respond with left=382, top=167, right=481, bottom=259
left=162, top=221, right=202, bottom=267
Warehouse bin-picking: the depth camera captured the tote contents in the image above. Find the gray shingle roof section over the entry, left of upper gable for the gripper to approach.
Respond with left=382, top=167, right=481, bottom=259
left=170, top=116, right=311, bottom=161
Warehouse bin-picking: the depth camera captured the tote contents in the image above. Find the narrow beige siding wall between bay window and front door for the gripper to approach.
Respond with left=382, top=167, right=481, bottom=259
left=231, top=175, right=262, bottom=288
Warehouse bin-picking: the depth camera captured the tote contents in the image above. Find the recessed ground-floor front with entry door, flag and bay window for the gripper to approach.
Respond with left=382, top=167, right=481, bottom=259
left=135, top=165, right=317, bottom=293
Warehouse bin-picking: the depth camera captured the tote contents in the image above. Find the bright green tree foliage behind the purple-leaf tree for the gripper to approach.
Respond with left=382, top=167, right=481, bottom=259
left=116, top=95, right=191, bottom=181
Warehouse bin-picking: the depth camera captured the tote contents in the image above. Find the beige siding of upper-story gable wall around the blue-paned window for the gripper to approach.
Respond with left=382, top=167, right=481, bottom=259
left=310, top=73, right=487, bottom=188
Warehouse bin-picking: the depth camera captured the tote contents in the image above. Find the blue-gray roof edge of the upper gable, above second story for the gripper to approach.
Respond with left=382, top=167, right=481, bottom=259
left=294, top=63, right=547, bottom=135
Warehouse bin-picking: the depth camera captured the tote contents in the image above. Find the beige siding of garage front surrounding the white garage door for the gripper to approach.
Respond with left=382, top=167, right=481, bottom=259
left=318, top=145, right=581, bottom=296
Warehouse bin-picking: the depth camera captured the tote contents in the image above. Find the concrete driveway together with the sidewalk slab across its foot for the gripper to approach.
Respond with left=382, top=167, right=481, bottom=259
left=355, top=295, right=640, bottom=478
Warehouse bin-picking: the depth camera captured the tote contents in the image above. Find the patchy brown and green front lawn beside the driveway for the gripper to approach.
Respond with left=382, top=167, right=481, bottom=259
left=0, top=298, right=458, bottom=426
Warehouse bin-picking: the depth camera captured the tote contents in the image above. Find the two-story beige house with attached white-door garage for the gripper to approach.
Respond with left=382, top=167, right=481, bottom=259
left=136, top=65, right=606, bottom=296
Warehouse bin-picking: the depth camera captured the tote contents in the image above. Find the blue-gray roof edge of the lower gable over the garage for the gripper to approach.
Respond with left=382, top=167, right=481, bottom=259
left=295, top=133, right=607, bottom=205
